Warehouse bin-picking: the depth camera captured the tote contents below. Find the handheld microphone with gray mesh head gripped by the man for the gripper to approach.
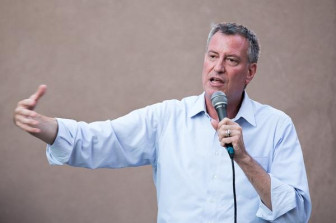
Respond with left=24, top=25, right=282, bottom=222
left=211, top=91, right=234, bottom=159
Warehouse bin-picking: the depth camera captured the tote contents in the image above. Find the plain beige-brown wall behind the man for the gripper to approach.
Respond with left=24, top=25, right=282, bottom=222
left=0, top=0, right=336, bottom=223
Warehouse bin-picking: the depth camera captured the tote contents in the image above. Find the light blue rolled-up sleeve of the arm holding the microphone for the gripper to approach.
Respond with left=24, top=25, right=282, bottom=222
left=256, top=118, right=311, bottom=223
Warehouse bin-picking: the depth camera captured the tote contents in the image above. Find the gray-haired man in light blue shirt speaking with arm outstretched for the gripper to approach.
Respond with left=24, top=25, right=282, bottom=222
left=14, top=23, right=311, bottom=223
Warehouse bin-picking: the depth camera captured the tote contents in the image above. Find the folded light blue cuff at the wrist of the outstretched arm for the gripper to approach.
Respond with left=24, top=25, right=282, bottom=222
left=46, top=118, right=77, bottom=165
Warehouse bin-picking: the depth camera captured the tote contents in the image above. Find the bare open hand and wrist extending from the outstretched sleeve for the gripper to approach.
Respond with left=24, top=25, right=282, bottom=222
left=14, top=85, right=58, bottom=144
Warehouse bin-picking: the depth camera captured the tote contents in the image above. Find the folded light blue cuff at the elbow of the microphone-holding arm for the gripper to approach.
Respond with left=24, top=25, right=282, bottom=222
left=256, top=174, right=296, bottom=221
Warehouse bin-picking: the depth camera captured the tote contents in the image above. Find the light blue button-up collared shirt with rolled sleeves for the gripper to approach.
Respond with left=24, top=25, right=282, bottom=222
left=47, top=92, right=311, bottom=223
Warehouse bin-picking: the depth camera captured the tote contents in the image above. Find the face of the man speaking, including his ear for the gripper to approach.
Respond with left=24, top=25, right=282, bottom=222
left=202, top=32, right=257, bottom=104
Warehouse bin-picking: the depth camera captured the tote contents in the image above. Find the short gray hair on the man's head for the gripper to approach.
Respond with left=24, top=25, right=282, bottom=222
left=207, top=23, right=260, bottom=63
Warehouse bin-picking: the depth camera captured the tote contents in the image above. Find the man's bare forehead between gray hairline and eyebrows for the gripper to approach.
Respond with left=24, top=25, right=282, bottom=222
left=208, top=32, right=249, bottom=55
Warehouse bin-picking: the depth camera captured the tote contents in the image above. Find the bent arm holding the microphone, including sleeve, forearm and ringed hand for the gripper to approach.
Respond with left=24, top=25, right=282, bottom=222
left=212, top=118, right=311, bottom=222
